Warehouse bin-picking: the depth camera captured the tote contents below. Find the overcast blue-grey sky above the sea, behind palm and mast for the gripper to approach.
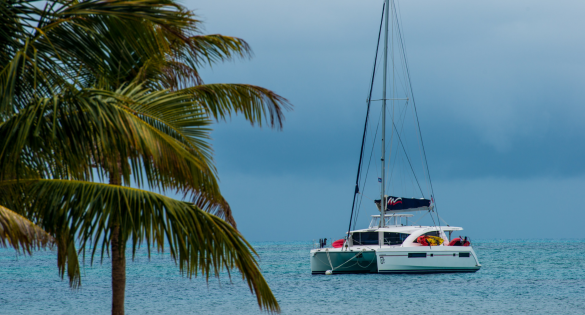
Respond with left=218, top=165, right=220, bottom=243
left=184, top=0, right=585, bottom=241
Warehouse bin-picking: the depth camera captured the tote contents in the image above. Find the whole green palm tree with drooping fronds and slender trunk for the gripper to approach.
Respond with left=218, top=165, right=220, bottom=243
left=0, top=0, right=289, bottom=314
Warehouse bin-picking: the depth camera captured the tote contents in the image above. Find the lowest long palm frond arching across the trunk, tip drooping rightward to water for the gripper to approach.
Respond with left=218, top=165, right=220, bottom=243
left=0, top=180, right=279, bottom=311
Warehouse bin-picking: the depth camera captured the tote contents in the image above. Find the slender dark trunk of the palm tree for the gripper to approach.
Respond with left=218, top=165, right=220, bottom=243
left=110, top=173, right=126, bottom=315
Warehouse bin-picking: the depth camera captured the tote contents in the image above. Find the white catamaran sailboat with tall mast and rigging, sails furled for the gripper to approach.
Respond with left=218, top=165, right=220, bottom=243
left=310, top=0, right=481, bottom=274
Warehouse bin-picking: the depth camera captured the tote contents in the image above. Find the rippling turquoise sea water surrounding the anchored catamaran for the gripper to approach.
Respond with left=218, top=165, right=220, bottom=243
left=0, top=240, right=585, bottom=314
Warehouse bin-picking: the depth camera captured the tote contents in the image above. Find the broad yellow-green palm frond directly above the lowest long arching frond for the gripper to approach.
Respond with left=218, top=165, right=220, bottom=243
left=0, top=87, right=218, bottom=193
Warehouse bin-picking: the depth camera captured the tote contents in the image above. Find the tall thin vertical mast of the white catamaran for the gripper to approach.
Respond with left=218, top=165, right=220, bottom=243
left=379, top=0, right=390, bottom=227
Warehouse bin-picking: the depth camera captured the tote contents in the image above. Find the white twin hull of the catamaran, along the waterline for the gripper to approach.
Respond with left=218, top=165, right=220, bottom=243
left=311, top=246, right=481, bottom=274
